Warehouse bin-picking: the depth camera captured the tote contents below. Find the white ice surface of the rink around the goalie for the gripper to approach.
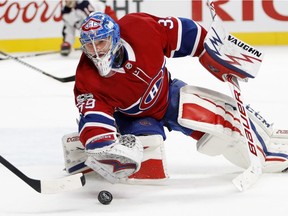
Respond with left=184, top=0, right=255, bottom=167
left=0, top=47, right=288, bottom=216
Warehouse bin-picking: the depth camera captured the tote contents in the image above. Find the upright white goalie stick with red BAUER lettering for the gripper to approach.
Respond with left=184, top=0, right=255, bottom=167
left=206, top=0, right=262, bottom=191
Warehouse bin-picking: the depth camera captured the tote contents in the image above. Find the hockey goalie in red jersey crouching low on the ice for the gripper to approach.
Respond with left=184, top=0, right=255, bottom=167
left=63, top=10, right=288, bottom=186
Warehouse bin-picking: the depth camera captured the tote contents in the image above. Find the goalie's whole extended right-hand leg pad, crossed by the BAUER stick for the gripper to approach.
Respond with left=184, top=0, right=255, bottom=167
left=178, top=86, right=288, bottom=172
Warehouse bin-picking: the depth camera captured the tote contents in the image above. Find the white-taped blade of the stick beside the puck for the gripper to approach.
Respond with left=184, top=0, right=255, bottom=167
left=38, top=173, right=86, bottom=194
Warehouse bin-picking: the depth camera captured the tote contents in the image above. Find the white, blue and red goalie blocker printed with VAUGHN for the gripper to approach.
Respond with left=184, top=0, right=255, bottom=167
left=199, top=13, right=264, bottom=81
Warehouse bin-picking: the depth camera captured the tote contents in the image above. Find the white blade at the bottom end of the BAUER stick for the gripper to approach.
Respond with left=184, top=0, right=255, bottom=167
left=232, top=166, right=262, bottom=191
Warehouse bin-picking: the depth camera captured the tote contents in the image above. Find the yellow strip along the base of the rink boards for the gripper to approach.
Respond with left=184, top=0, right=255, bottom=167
left=0, top=32, right=288, bottom=52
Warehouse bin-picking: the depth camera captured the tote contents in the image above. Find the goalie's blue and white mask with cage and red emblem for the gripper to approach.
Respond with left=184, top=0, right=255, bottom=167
left=80, top=12, right=121, bottom=77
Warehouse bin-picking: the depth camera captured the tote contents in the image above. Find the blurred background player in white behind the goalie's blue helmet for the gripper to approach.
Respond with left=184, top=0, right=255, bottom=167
left=60, top=0, right=118, bottom=56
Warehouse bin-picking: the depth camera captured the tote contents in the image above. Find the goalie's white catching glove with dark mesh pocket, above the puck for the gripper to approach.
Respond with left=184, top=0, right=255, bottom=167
left=85, top=134, right=143, bottom=183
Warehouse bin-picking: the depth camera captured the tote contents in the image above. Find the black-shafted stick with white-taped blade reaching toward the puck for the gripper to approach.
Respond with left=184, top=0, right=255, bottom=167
left=0, top=155, right=86, bottom=194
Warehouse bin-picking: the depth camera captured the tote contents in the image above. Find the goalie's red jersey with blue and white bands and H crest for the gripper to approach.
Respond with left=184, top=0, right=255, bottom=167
left=74, top=13, right=206, bottom=146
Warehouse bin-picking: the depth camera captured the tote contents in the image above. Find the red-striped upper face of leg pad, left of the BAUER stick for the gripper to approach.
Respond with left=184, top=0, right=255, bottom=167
left=178, top=85, right=243, bottom=141
